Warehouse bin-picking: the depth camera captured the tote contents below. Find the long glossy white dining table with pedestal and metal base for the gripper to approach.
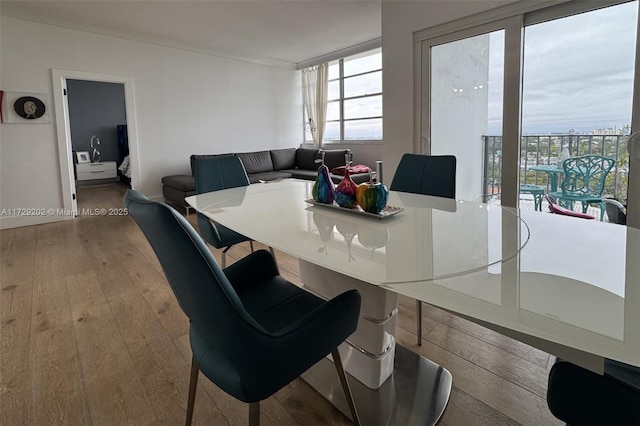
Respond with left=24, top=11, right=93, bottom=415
left=186, top=179, right=640, bottom=424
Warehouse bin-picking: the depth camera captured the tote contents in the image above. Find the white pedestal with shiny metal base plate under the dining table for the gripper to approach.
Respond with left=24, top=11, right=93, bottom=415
left=300, top=260, right=452, bottom=425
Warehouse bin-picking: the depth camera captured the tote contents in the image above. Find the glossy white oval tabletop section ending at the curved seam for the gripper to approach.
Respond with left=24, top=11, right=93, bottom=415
left=188, top=181, right=529, bottom=284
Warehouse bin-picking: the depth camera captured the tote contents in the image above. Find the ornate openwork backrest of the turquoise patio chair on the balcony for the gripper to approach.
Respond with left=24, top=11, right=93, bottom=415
left=560, top=155, right=615, bottom=197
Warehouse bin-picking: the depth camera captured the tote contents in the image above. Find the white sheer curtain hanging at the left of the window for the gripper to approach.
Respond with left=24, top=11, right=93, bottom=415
left=302, top=64, right=329, bottom=148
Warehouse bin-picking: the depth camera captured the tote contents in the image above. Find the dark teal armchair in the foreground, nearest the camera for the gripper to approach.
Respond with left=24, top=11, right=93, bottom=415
left=124, top=190, right=360, bottom=426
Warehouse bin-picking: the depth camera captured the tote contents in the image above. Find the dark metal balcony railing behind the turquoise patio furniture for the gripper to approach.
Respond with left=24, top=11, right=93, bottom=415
left=482, top=134, right=629, bottom=202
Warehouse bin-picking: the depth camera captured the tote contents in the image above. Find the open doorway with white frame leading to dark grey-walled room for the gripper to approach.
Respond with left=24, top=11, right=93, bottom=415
left=52, top=69, right=139, bottom=215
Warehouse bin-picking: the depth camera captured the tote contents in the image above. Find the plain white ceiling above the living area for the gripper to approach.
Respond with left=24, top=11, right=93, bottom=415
left=0, top=0, right=381, bottom=67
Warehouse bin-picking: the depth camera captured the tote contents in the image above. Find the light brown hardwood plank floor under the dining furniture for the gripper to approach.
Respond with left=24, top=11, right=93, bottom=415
left=0, top=185, right=560, bottom=426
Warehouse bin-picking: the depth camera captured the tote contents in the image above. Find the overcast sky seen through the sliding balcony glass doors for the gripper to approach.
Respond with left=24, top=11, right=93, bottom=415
left=489, top=2, right=638, bottom=133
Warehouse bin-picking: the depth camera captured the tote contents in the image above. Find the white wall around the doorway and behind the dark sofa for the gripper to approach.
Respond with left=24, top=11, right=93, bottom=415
left=0, top=17, right=302, bottom=228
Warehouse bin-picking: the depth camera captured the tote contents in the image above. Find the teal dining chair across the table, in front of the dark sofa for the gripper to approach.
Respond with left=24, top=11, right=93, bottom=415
left=193, top=155, right=258, bottom=268
